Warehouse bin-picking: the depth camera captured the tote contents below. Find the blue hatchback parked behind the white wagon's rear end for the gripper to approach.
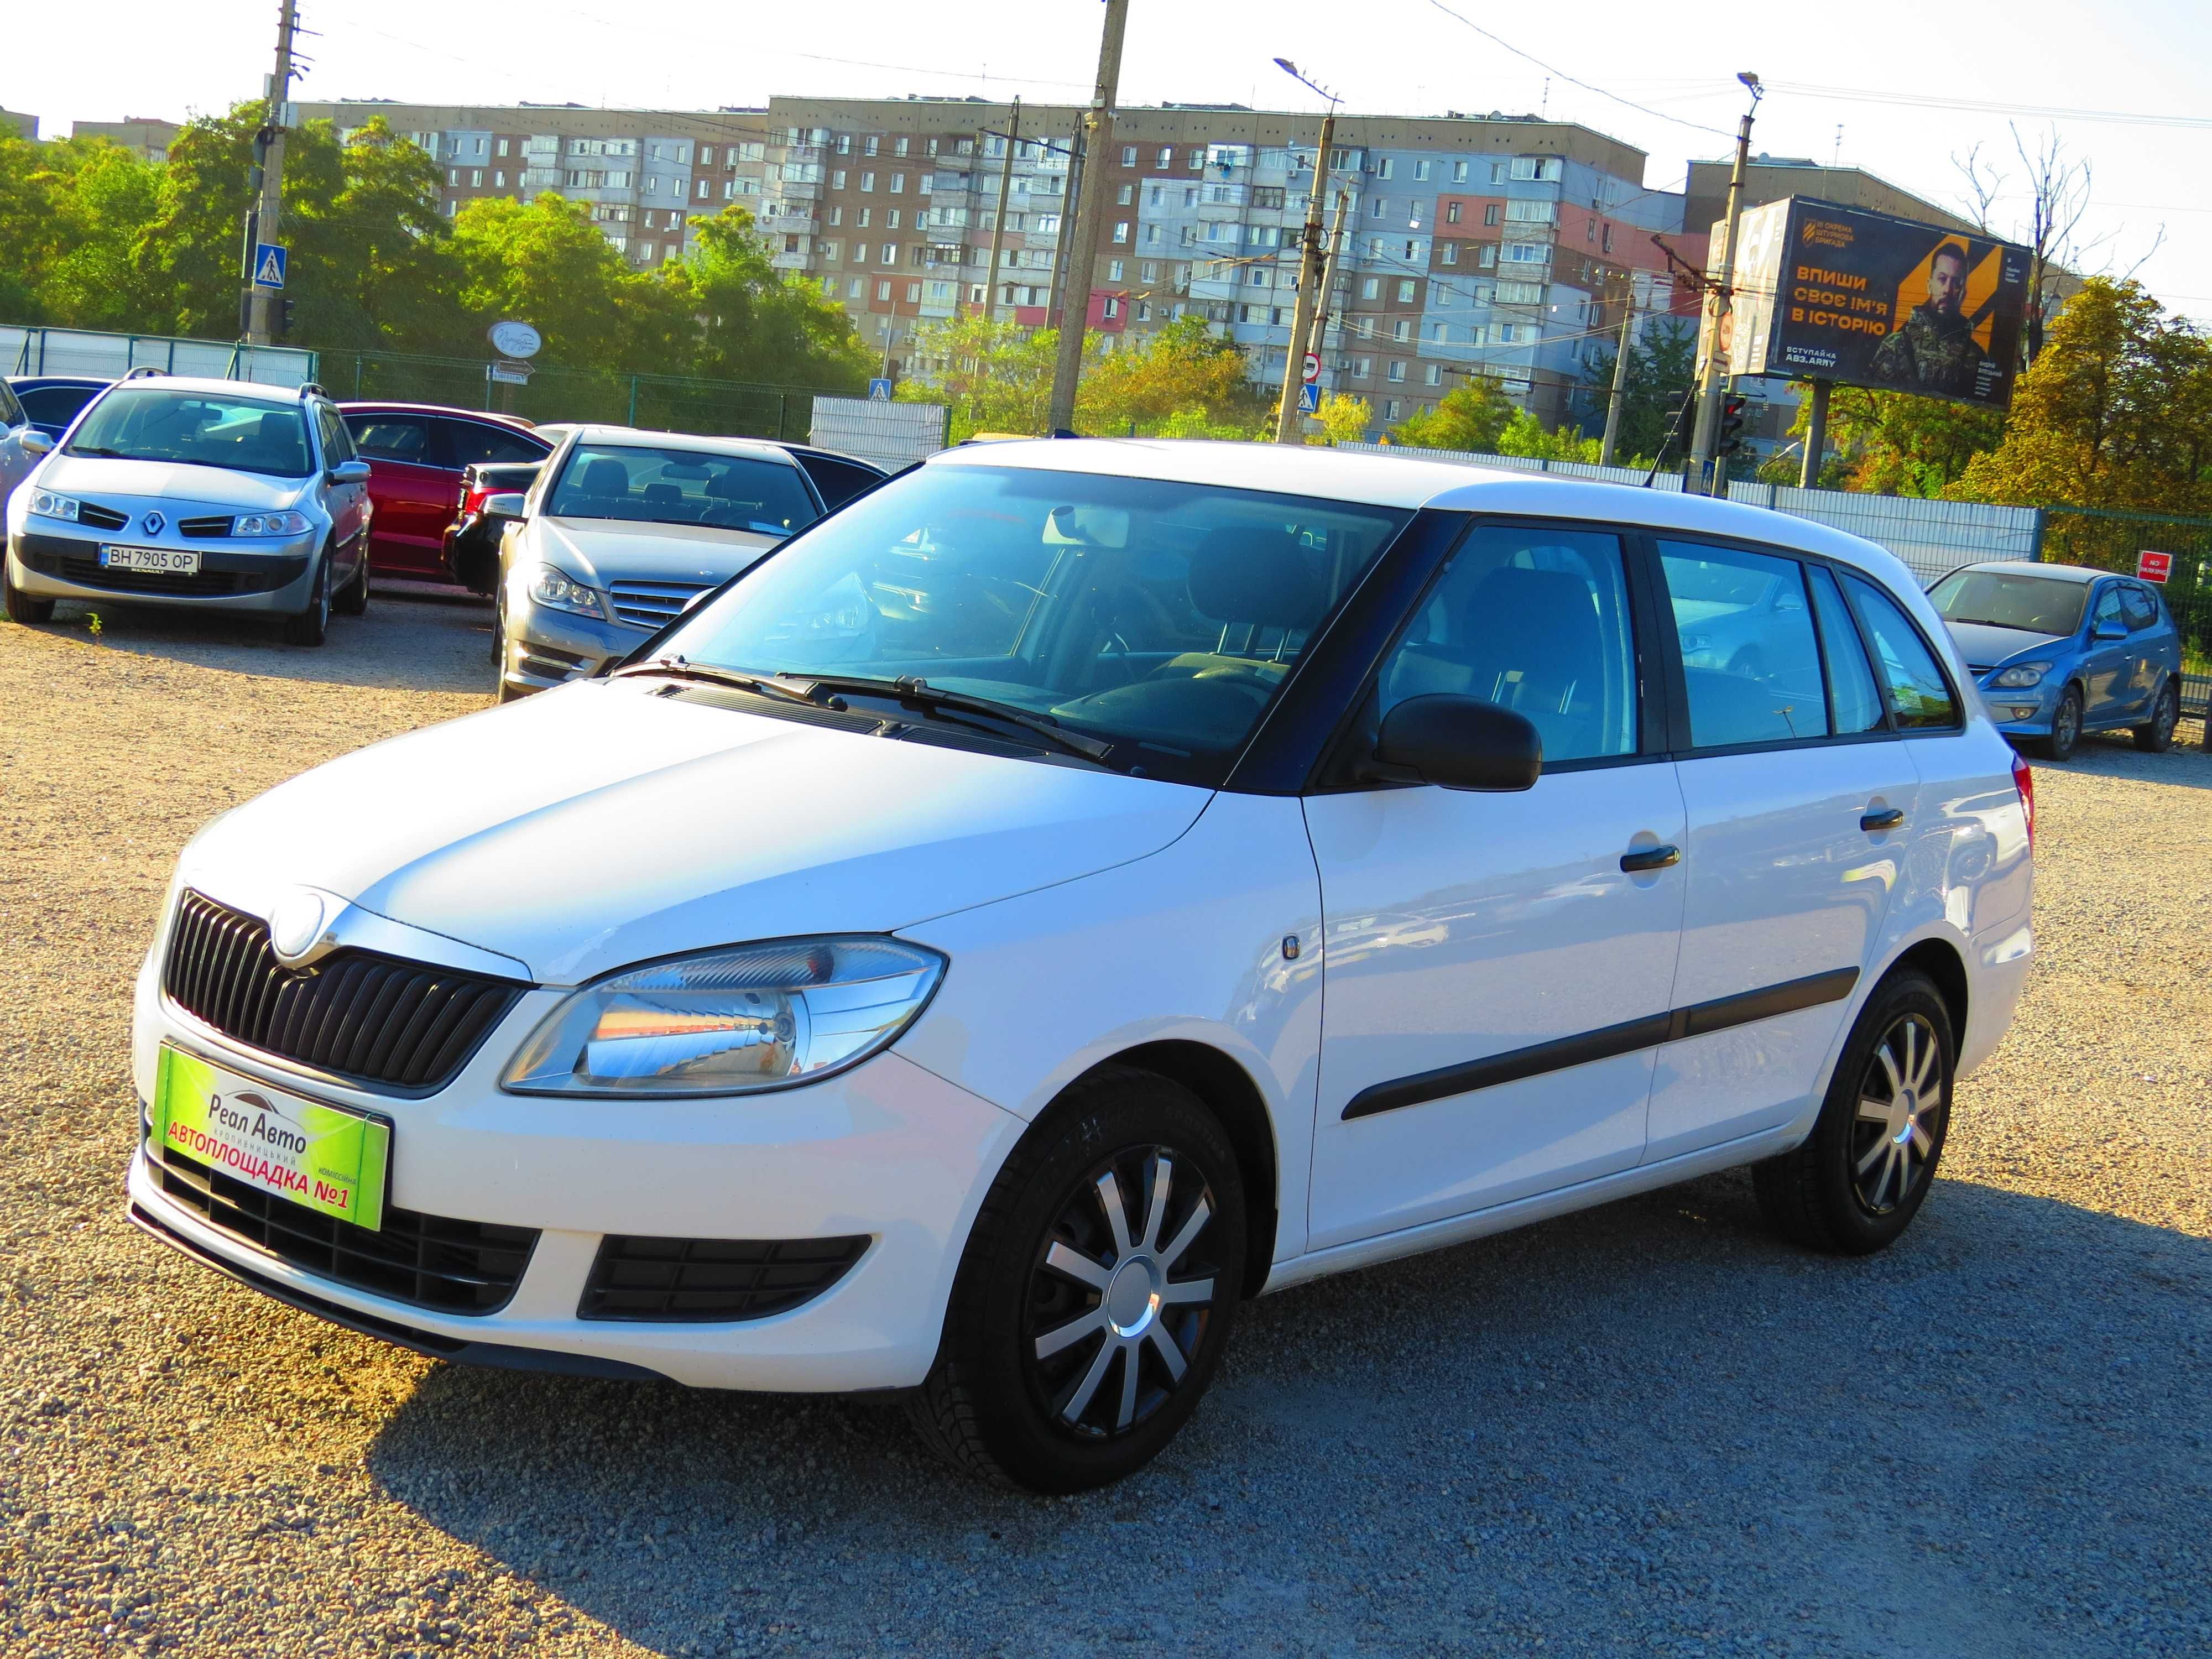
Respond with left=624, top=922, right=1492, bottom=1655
left=1929, top=564, right=2181, bottom=761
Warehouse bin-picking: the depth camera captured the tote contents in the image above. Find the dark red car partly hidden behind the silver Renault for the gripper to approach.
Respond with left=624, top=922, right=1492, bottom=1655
left=338, top=403, right=553, bottom=582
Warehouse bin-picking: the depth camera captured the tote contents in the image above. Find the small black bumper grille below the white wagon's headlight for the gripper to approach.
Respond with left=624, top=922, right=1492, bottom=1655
left=575, top=1234, right=867, bottom=1323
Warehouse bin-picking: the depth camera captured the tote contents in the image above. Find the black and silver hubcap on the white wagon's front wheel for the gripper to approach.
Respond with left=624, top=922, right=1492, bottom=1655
left=1022, top=1146, right=1214, bottom=1438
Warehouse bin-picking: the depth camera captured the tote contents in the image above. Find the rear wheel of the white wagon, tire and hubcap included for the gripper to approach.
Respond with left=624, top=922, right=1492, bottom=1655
left=1752, top=969, right=1958, bottom=1256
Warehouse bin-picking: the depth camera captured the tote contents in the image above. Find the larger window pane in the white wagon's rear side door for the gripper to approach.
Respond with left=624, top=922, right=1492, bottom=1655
left=1659, top=542, right=1829, bottom=750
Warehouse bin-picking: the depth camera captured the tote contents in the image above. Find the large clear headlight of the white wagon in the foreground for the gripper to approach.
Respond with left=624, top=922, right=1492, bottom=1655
left=500, top=936, right=945, bottom=1095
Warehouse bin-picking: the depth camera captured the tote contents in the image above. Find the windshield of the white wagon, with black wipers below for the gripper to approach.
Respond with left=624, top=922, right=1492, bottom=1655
left=661, top=465, right=1411, bottom=783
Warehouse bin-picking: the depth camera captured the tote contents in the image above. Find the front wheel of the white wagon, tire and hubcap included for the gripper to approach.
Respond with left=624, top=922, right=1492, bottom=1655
left=907, top=1066, right=1245, bottom=1493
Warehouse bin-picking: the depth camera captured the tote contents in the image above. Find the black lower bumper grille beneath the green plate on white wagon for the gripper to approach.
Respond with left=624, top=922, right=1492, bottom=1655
left=153, top=1146, right=538, bottom=1314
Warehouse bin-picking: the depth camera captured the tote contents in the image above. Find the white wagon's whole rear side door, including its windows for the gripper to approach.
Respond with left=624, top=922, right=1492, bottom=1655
left=1644, top=538, right=1920, bottom=1164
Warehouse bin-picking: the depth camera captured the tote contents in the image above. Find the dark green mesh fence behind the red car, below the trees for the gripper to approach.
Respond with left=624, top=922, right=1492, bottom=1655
left=321, top=352, right=836, bottom=442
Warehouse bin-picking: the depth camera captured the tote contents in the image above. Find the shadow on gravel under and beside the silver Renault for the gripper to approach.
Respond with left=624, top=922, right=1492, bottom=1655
left=40, top=586, right=493, bottom=701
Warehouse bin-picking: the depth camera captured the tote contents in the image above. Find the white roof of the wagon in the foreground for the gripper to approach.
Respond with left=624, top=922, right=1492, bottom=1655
left=929, top=438, right=1920, bottom=593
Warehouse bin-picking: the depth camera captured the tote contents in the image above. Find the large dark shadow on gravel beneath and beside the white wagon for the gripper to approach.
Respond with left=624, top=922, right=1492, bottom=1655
left=369, top=1177, right=2212, bottom=1657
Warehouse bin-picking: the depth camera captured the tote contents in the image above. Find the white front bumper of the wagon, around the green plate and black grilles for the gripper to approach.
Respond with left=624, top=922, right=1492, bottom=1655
left=128, top=960, right=1022, bottom=1394
